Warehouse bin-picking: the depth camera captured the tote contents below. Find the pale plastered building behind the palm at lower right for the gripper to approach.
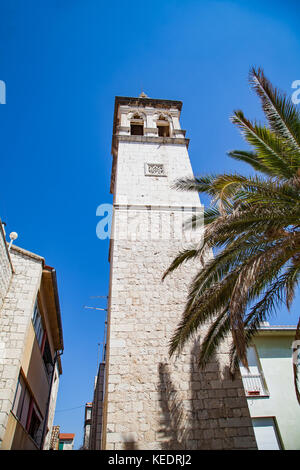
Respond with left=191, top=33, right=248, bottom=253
left=241, top=323, right=300, bottom=450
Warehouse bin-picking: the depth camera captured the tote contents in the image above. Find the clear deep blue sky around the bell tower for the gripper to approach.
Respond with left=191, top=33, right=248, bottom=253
left=0, top=0, right=300, bottom=448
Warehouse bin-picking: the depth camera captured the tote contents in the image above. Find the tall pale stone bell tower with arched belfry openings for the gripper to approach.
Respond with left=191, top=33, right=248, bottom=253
left=101, top=94, right=256, bottom=450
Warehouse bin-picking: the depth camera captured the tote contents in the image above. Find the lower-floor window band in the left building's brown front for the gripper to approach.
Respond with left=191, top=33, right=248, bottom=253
left=12, top=374, right=42, bottom=443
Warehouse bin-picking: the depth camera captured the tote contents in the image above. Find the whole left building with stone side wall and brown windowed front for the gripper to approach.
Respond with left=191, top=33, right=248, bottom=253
left=0, top=218, right=63, bottom=450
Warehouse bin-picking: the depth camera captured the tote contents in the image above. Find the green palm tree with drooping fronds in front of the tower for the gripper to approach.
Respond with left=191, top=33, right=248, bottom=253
left=163, top=68, right=300, bottom=403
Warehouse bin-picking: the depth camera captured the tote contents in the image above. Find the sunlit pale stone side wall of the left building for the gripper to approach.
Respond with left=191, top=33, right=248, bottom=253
left=0, top=248, right=42, bottom=448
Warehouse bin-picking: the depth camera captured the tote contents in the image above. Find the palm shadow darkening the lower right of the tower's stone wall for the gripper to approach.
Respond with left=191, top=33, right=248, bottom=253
left=124, top=342, right=255, bottom=450
